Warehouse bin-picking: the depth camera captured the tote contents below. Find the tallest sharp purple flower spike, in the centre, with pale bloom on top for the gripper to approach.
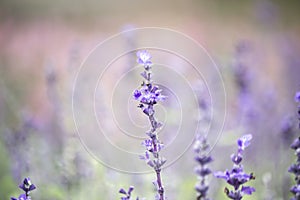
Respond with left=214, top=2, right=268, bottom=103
left=133, top=50, right=166, bottom=200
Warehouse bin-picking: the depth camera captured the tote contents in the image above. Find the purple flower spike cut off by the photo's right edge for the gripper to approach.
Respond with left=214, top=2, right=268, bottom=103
left=288, top=92, right=300, bottom=200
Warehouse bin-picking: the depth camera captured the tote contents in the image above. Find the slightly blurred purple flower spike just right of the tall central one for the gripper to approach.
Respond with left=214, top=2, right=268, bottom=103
left=194, top=136, right=213, bottom=200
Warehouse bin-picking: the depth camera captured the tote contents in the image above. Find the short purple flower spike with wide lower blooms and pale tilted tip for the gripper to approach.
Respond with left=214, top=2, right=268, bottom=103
left=214, top=134, right=255, bottom=200
